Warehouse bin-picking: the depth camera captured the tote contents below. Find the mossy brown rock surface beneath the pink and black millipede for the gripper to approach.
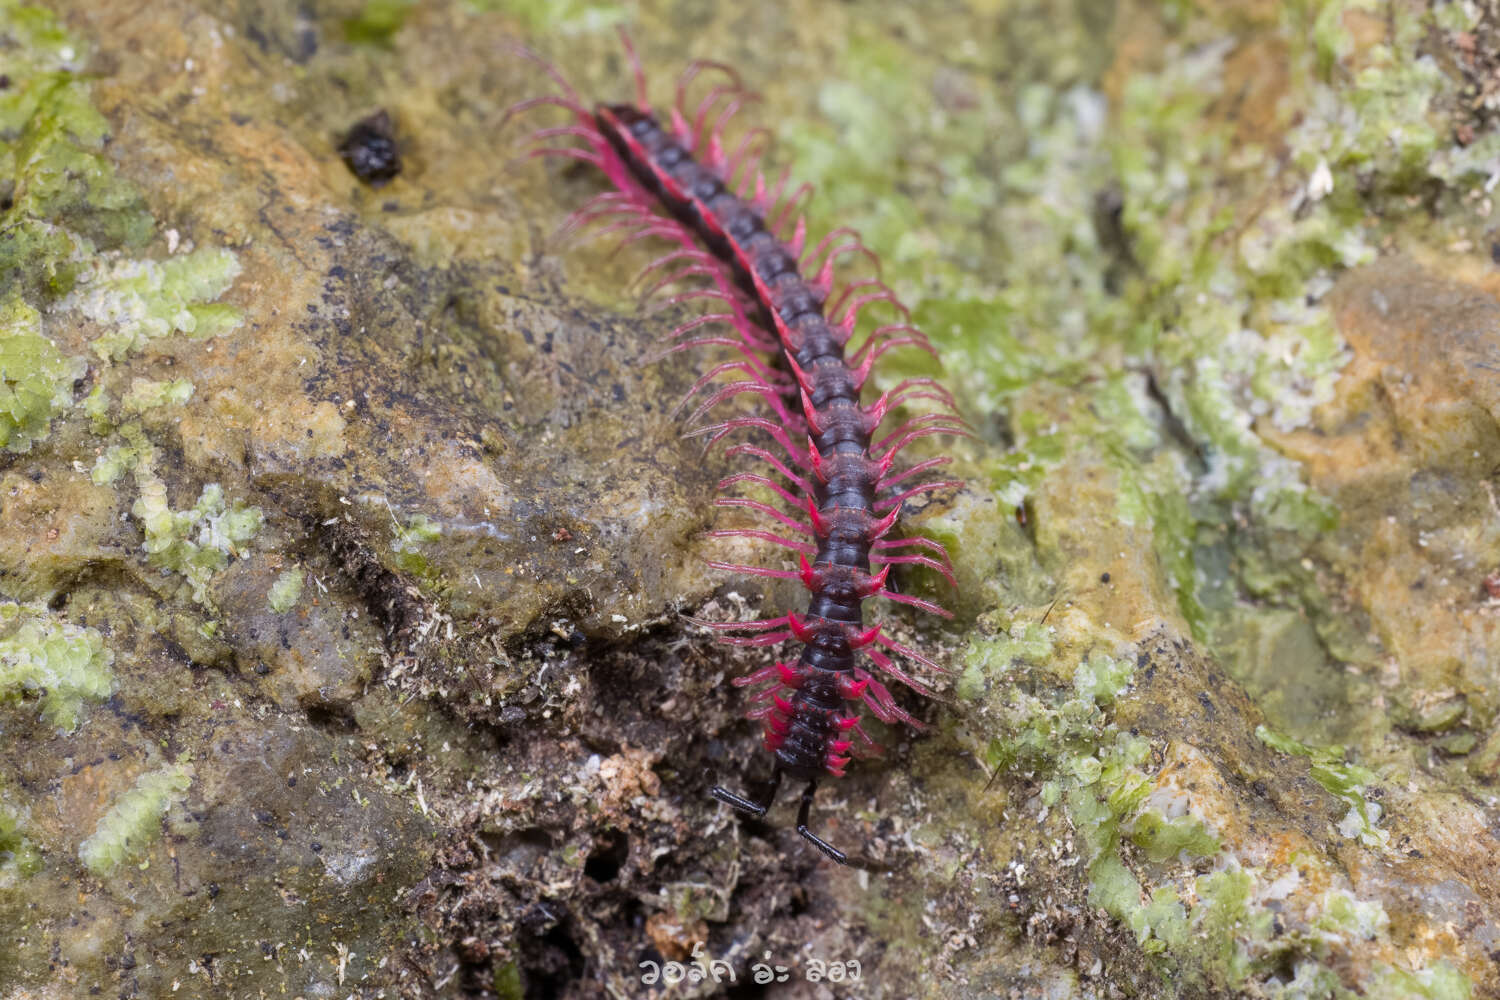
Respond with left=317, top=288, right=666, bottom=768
left=0, top=0, right=1500, bottom=1000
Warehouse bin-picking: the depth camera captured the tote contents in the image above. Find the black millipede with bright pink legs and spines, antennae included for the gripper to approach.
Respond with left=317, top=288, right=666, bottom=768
left=510, top=36, right=968, bottom=864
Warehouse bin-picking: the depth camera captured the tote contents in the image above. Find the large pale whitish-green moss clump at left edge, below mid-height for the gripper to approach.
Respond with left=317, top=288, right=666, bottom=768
left=0, top=603, right=114, bottom=732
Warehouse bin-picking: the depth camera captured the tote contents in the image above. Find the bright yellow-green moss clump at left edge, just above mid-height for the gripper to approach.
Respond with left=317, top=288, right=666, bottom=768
left=0, top=294, right=89, bottom=451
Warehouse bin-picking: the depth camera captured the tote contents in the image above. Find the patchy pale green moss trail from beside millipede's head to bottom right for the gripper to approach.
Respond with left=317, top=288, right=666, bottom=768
left=965, top=625, right=1469, bottom=1000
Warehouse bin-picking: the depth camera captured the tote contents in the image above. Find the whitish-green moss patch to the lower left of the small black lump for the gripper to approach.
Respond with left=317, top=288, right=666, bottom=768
left=60, top=249, right=240, bottom=361
